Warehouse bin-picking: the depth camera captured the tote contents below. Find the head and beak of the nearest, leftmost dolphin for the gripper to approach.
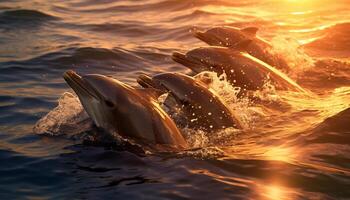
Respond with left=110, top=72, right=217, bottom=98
left=63, top=70, right=130, bottom=130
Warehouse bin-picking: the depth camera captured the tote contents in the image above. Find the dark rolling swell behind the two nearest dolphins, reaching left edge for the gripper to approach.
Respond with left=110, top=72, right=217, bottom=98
left=0, top=46, right=180, bottom=84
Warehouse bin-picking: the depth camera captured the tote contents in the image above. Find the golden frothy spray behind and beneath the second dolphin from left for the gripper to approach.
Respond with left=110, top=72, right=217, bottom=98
left=175, top=72, right=281, bottom=152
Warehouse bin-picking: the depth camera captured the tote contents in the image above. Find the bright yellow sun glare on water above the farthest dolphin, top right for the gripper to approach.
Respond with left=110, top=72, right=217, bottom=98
left=201, top=0, right=348, bottom=44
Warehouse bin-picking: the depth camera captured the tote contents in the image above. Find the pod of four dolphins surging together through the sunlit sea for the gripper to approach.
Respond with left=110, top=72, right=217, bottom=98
left=63, top=27, right=307, bottom=150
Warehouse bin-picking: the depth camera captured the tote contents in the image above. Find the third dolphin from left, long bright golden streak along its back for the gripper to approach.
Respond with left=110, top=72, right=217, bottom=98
left=172, top=46, right=306, bottom=93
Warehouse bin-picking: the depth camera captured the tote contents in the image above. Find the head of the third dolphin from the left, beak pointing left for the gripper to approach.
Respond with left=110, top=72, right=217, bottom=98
left=172, top=47, right=238, bottom=73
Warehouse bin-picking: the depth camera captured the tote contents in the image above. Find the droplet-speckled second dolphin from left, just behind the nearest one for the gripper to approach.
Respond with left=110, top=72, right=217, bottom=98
left=137, top=73, right=243, bottom=132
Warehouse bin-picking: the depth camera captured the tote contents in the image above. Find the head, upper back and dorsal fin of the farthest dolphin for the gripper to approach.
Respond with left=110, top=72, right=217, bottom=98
left=194, top=26, right=258, bottom=47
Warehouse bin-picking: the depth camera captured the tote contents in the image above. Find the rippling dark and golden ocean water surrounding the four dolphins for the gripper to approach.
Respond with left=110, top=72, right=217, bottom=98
left=0, top=0, right=350, bottom=199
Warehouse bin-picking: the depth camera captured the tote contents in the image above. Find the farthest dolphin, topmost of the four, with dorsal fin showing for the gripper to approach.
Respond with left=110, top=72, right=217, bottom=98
left=193, top=26, right=290, bottom=71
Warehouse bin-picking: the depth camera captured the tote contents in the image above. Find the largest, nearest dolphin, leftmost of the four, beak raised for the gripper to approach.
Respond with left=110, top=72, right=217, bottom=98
left=63, top=70, right=188, bottom=149
